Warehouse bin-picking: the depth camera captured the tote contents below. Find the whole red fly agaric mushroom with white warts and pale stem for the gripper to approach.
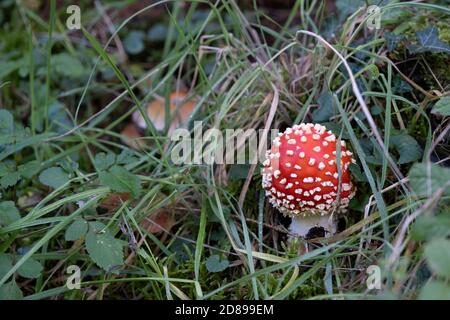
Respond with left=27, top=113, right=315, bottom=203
left=262, top=123, right=355, bottom=238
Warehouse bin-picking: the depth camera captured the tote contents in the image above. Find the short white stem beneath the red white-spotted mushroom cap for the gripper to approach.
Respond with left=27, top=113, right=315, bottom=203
left=289, top=214, right=336, bottom=239
